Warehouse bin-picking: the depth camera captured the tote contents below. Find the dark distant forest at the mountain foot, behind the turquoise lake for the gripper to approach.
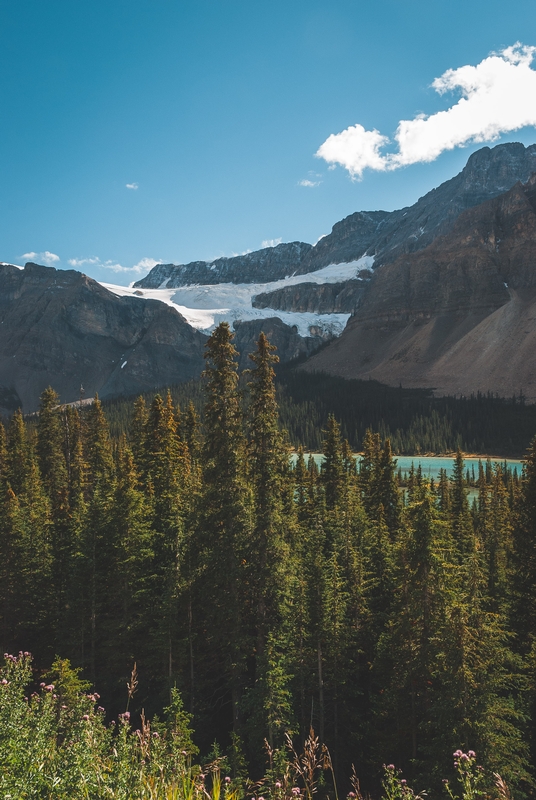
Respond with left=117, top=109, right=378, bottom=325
left=104, top=364, right=536, bottom=457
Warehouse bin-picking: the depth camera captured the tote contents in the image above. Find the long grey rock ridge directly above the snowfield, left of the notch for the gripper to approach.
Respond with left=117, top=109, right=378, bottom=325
left=134, top=242, right=312, bottom=289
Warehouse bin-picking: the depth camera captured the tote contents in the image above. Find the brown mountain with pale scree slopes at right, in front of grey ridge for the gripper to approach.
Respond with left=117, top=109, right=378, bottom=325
left=307, top=178, right=536, bottom=400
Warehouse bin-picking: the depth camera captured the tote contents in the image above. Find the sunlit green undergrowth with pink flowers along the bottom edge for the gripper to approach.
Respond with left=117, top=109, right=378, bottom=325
left=0, top=652, right=511, bottom=800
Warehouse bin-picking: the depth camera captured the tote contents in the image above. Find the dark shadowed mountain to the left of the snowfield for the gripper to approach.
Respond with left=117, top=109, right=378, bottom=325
left=0, top=263, right=206, bottom=413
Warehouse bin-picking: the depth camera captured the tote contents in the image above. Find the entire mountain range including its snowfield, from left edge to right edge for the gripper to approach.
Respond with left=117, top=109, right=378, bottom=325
left=4, top=144, right=536, bottom=412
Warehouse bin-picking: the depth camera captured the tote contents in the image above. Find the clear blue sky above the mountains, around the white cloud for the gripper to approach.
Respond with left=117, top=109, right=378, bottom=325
left=0, top=0, right=536, bottom=284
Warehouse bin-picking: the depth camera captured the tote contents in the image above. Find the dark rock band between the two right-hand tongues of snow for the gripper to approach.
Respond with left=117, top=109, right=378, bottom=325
left=252, top=280, right=366, bottom=314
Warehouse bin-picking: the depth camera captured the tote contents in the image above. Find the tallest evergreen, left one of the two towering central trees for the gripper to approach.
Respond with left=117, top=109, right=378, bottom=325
left=192, top=322, right=253, bottom=733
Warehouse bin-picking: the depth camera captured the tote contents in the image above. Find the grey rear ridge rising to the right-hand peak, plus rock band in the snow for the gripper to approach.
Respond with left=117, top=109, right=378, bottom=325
left=134, top=142, right=536, bottom=322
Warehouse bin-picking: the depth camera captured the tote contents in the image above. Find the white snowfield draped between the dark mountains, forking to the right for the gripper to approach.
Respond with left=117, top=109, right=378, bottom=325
left=102, top=256, right=374, bottom=336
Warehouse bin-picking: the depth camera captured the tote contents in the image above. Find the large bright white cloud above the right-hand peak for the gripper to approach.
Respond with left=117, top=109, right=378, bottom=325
left=315, top=42, right=536, bottom=179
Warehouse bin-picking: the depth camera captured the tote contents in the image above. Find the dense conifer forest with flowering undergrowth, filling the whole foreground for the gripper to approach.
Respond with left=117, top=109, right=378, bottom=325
left=0, top=323, right=536, bottom=800
